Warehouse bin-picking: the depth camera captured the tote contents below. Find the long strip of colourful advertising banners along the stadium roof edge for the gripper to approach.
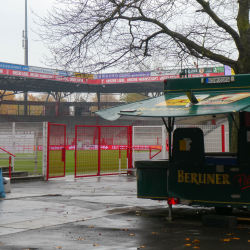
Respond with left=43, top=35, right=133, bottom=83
left=0, top=63, right=226, bottom=84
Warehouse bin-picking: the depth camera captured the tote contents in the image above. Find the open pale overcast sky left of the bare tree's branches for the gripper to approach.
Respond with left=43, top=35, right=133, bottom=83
left=0, top=0, right=54, bottom=67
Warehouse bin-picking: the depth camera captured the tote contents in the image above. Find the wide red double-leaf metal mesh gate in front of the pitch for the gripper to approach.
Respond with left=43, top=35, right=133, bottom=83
left=75, top=125, right=132, bottom=178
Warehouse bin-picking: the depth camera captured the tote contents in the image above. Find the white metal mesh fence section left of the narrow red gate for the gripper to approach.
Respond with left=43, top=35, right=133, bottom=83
left=0, top=122, right=47, bottom=175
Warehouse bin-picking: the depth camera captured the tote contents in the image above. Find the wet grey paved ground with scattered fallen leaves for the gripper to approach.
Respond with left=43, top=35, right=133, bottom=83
left=0, top=176, right=250, bottom=250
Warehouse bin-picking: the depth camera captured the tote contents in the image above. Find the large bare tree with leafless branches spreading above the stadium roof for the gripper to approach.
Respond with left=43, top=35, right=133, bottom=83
left=39, top=0, right=250, bottom=73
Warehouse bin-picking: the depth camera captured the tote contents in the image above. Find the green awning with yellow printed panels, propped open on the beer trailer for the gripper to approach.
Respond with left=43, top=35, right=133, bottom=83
left=95, top=91, right=250, bottom=121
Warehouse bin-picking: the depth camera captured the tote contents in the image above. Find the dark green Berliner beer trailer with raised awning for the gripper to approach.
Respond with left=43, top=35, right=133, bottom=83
left=96, top=75, right=250, bottom=218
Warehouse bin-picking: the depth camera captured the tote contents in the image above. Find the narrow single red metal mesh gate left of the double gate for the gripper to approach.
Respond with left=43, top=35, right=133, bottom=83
left=47, top=123, right=66, bottom=180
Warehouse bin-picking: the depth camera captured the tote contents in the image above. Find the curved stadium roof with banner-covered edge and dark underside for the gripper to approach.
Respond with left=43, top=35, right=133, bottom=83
left=0, top=62, right=225, bottom=93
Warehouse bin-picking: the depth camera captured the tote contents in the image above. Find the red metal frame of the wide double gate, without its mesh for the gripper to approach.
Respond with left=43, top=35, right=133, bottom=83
left=75, top=125, right=133, bottom=178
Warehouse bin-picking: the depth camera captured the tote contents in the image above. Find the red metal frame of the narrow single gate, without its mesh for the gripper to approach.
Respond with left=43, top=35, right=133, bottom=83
left=46, top=122, right=66, bottom=180
